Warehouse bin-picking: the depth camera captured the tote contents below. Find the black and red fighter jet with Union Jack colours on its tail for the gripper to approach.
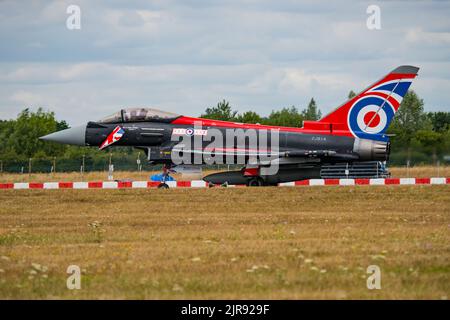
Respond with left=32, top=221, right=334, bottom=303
left=40, top=66, right=419, bottom=188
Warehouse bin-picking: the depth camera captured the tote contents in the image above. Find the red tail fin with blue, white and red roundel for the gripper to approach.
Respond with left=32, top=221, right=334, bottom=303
left=320, top=66, right=419, bottom=140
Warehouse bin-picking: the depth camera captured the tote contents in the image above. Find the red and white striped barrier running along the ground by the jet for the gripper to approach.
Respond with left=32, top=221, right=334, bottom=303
left=0, top=178, right=450, bottom=189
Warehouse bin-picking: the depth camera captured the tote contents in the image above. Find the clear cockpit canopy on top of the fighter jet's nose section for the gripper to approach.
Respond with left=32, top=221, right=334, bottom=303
left=97, top=108, right=180, bottom=123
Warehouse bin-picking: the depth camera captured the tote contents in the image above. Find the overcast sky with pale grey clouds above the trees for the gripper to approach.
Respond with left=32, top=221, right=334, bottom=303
left=0, top=0, right=450, bottom=125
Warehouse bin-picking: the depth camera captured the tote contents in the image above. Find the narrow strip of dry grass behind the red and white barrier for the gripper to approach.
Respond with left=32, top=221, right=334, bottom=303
left=0, top=166, right=450, bottom=182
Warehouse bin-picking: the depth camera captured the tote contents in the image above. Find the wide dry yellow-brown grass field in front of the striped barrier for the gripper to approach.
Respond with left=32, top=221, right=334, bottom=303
left=0, top=185, right=450, bottom=299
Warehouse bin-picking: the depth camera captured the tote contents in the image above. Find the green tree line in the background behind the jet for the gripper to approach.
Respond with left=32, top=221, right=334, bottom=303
left=0, top=91, right=450, bottom=171
